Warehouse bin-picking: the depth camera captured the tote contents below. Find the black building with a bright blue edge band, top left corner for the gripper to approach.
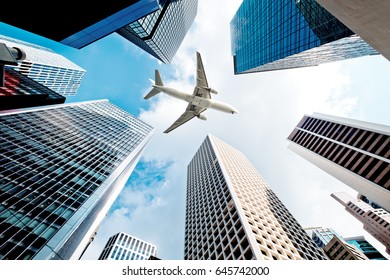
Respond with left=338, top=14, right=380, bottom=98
left=0, top=0, right=160, bottom=49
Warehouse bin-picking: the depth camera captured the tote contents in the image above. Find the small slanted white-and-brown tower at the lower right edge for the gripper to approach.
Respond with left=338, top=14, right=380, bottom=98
left=331, top=192, right=390, bottom=254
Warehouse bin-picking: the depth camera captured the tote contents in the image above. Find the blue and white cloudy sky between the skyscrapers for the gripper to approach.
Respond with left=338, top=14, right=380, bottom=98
left=0, top=0, right=390, bottom=260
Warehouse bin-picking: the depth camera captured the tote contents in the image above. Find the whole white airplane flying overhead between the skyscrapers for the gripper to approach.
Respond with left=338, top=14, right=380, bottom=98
left=144, top=52, right=239, bottom=133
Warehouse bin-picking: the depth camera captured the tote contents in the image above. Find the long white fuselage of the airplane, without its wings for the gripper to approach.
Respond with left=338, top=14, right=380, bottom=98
left=153, top=85, right=238, bottom=114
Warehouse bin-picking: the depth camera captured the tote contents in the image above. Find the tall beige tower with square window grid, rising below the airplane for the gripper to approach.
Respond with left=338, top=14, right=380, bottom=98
left=184, top=135, right=325, bottom=260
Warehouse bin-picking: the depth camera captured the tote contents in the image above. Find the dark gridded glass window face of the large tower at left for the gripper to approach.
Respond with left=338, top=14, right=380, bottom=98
left=0, top=102, right=152, bottom=259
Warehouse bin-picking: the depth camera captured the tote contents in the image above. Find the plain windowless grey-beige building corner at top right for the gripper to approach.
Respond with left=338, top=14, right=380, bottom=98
left=316, top=0, right=390, bottom=60
